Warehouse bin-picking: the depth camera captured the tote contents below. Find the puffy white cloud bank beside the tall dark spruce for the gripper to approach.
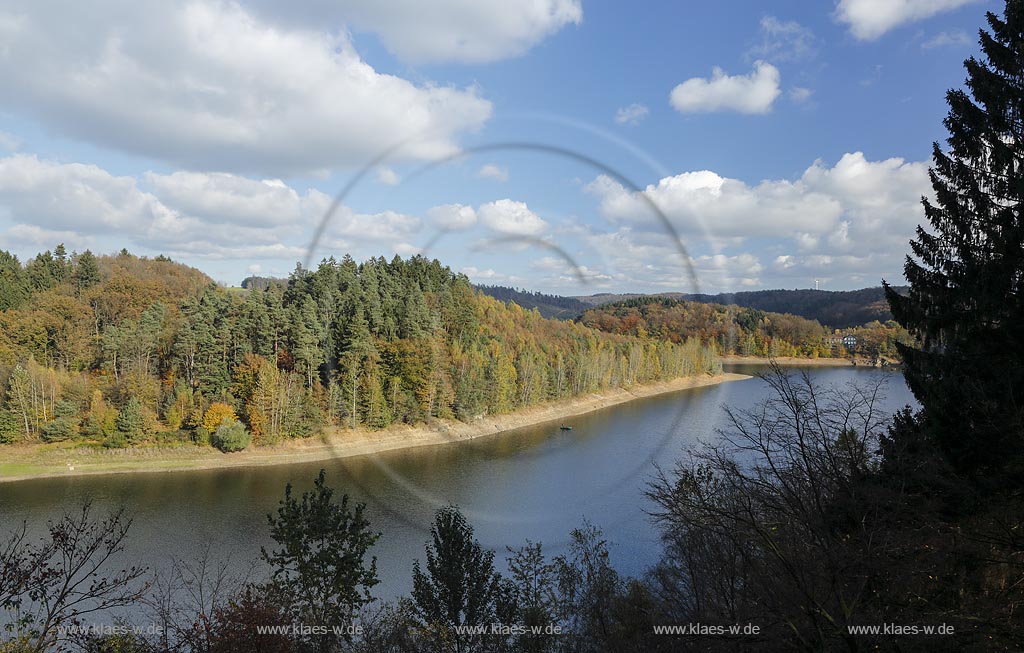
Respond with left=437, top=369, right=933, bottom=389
left=586, top=153, right=931, bottom=252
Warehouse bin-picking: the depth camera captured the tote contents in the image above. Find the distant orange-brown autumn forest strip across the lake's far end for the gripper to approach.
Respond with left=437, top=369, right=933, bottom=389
left=580, top=296, right=911, bottom=361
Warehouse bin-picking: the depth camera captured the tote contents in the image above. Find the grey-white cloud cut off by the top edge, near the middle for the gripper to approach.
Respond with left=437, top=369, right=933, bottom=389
left=249, top=0, right=583, bottom=63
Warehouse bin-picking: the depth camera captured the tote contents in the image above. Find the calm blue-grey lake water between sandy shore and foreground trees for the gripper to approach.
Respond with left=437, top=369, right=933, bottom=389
left=0, top=366, right=912, bottom=610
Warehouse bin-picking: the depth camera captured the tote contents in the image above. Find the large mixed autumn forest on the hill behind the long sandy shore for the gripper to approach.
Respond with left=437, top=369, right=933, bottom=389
left=0, top=246, right=718, bottom=451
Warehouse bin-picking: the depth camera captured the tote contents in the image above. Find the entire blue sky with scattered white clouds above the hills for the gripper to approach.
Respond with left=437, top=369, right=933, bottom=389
left=0, top=0, right=999, bottom=294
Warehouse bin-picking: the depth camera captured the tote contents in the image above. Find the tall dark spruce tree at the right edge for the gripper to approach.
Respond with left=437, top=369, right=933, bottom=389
left=886, top=0, right=1024, bottom=482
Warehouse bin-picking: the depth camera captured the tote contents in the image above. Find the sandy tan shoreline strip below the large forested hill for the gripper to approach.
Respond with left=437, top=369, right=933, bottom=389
left=0, top=373, right=752, bottom=483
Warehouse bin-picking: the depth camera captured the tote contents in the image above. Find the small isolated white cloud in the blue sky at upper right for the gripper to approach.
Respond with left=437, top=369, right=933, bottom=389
left=669, top=61, right=780, bottom=114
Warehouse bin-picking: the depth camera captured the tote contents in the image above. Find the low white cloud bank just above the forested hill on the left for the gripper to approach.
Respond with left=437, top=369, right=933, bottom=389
left=0, top=155, right=421, bottom=261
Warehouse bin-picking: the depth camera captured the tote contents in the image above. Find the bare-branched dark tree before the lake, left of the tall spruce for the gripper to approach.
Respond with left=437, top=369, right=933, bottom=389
left=648, top=366, right=897, bottom=650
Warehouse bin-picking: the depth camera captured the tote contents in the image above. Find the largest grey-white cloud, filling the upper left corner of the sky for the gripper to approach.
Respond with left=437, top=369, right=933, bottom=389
left=0, top=0, right=492, bottom=176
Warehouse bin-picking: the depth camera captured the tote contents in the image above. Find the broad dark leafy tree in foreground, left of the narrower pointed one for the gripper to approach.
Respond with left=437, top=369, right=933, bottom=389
left=263, top=470, right=380, bottom=652
